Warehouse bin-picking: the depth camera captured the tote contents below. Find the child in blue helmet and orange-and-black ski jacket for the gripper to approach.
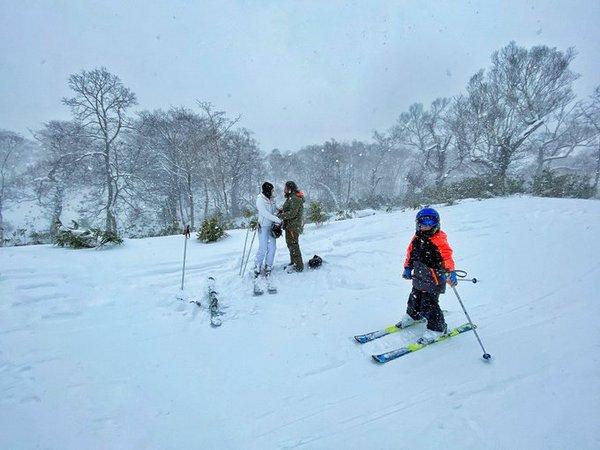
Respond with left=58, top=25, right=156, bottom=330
left=396, top=208, right=457, bottom=343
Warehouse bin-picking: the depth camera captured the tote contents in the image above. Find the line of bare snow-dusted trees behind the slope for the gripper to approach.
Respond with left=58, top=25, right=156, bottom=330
left=0, top=42, right=600, bottom=244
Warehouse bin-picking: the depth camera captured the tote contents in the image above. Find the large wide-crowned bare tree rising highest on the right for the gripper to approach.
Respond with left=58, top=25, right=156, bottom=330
left=456, top=42, right=577, bottom=192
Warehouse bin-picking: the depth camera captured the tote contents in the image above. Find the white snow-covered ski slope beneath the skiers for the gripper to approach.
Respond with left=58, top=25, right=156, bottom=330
left=0, top=198, right=600, bottom=449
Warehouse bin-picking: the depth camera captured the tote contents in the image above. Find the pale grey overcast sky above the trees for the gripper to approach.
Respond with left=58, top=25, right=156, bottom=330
left=0, top=0, right=600, bottom=151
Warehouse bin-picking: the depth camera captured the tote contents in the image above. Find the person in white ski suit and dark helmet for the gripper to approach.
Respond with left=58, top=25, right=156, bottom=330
left=254, top=182, right=282, bottom=274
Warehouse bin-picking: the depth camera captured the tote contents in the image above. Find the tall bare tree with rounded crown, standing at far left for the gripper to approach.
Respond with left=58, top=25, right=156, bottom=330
left=63, top=67, right=137, bottom=232
